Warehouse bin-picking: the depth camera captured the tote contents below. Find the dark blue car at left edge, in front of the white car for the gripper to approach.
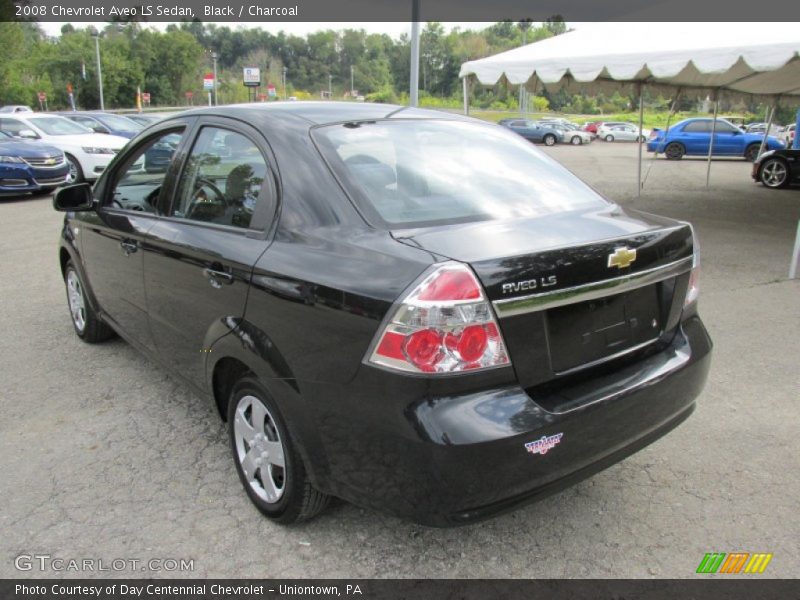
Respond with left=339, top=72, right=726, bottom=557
left=0, top=131, right=69, bottom=196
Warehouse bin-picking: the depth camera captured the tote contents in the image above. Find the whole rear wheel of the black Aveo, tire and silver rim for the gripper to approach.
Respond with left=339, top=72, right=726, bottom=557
left=228, top=377, right=329, bottom=524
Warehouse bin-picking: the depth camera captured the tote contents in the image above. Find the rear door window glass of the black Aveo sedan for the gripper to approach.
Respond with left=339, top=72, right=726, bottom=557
left=173, top=127, right=267, bottom=228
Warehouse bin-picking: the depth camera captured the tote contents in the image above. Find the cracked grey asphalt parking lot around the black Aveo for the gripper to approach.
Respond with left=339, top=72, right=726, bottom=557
left=0, top=142, right=800, bottom=578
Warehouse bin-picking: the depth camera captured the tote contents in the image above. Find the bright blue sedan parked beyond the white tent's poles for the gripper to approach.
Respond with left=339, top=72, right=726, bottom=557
left=647, top=118, right=784, bottom=162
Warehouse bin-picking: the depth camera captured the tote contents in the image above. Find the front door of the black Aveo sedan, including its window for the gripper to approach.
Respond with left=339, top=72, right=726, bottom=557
left=79, top=126, right=190, bottom=349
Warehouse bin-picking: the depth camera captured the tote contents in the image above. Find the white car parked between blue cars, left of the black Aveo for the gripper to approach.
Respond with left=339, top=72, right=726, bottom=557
left=0, top=113, right=128, bottom=184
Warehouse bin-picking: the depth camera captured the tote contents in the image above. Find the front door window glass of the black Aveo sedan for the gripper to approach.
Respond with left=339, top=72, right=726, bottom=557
left=109, top=130, right=183, bottom=213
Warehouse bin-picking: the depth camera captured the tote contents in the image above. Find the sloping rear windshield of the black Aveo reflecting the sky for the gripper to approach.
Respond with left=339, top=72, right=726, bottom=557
left=314, top=119, right=607, bottom=227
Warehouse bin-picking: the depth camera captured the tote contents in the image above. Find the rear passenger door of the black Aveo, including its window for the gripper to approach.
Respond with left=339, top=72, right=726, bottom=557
left=144, top=117, right=277, bottom=386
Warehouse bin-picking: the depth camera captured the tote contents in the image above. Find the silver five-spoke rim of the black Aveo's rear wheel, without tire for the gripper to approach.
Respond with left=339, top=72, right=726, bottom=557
left=233, top=395, right=286, bottom=504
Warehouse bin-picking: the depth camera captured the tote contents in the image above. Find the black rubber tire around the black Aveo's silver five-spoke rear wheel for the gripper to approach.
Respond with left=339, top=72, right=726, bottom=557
left=227, top=376, right=330, bottom=525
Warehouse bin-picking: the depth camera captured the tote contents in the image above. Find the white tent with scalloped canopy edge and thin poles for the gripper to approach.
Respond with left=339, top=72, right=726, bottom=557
left=460, top=23, right=800, bottom=192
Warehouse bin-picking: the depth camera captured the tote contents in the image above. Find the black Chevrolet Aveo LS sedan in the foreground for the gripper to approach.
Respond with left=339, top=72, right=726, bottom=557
left=54, top=103, right=711, bottom=526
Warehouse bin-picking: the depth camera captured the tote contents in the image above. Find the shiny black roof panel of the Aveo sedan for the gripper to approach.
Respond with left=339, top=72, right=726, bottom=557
left=167, top=101, right=474, bottom=127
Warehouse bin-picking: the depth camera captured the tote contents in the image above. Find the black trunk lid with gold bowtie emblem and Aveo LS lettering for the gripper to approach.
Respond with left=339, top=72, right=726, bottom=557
left=392, top=207, right=693, bottom=387
